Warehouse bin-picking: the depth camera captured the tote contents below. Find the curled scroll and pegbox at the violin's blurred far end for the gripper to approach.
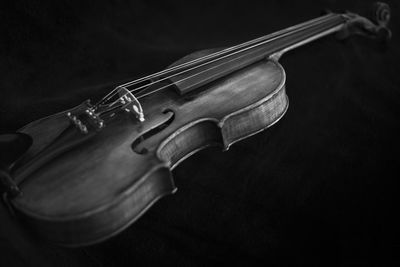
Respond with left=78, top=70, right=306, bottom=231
left=337, top=2, right=392, bottom=41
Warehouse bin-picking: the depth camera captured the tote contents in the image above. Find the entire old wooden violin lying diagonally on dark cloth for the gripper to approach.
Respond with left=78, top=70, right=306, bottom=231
left=0, top=3, right=391, bottom=246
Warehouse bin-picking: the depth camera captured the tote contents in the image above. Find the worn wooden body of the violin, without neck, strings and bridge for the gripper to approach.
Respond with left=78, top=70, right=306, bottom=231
left=12, top=51, right=288, bottom=246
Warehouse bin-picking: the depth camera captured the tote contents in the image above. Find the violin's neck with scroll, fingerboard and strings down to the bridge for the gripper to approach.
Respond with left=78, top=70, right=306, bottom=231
left=93, top=2, right=391, bottom=105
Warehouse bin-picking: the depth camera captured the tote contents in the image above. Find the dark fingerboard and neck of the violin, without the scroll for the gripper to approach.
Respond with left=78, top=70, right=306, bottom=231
left=170, top=14, right=346, bottom=94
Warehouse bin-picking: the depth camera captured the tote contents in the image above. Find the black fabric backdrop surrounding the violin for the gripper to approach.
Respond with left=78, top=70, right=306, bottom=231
left=0, top=0, right=400, bottom=266
